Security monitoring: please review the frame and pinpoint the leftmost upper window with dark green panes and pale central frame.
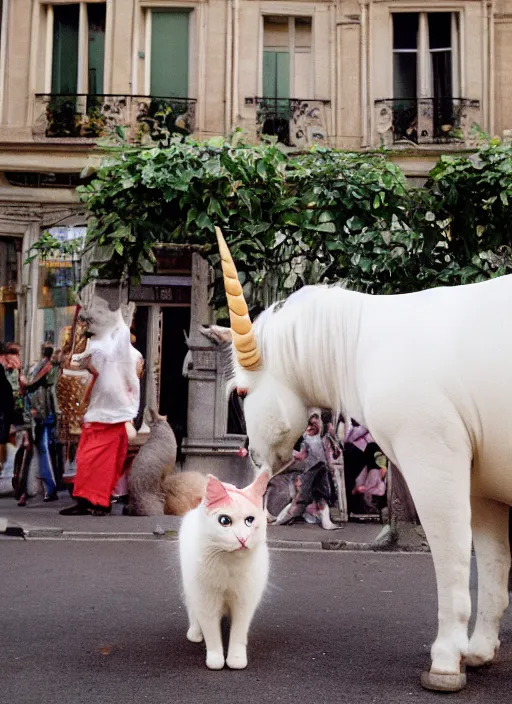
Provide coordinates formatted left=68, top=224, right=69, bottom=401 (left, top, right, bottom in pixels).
left=48, top=3, right=106, bottom=95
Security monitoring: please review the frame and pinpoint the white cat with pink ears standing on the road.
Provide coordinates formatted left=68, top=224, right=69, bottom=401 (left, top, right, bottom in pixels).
left=179, top=473, right=269, bottom=670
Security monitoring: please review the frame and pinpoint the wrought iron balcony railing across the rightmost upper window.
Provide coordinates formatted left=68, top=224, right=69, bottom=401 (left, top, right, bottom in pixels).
left=375, top=98, right=480, bottom=146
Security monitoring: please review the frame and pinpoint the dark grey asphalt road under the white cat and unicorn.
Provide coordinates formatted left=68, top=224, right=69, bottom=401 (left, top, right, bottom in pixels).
left=0, top=539, right=512, bottom=704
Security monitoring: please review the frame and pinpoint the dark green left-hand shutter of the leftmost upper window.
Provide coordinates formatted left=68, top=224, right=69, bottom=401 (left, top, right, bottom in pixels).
left=52, top=4, right=80, bottom=95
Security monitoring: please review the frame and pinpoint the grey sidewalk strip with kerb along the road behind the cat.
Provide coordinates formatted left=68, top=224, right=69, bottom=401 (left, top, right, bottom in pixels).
left=0, top=492, right=421, bottom=550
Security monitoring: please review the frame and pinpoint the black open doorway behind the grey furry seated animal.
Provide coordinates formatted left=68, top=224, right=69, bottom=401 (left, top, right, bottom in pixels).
left=159, top=306, right=190, bottom=452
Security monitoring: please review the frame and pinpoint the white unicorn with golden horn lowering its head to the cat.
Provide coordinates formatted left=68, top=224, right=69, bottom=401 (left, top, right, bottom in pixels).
left=212, top=228, right=512, bottom=691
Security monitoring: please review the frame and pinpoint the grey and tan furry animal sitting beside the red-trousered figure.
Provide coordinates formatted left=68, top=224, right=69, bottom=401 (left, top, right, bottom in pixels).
left=127, top=409, right=206, bottom=516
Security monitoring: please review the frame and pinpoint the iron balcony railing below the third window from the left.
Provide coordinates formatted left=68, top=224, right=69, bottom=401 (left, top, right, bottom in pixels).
left=245, top=98, right=331, bottom=149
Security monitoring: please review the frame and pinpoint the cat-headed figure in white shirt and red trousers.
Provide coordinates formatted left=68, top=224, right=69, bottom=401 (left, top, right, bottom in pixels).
left=61, top=296, right=143, bottom=515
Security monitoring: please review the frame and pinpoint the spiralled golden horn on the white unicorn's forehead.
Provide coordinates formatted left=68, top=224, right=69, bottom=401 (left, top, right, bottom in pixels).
left=215, top=227, right=261, bottom=371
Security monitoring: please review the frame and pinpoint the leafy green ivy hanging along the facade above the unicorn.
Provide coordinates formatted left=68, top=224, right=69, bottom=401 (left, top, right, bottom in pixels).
left=28, top=133, right=512, bottom=317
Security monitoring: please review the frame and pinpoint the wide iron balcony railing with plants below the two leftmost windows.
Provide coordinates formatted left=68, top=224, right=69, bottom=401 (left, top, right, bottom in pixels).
left=32, top=94, right=196, bottom=142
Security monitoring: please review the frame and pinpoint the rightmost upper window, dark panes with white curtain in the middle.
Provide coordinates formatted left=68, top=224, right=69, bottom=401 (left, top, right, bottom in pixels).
left=392, top=12, right=461, bottom=142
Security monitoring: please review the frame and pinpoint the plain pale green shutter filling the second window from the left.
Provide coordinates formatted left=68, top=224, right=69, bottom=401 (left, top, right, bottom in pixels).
left=151, top=10, right=190, bottom=98
